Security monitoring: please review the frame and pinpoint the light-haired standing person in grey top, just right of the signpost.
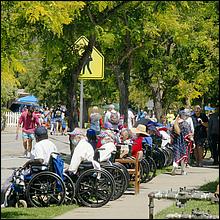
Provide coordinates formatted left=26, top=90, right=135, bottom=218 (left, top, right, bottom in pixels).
left=90, top=106, right=103, bottom=135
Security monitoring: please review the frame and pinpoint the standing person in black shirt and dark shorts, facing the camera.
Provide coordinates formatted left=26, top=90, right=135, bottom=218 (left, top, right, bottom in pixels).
left=192, top=105, right=208, bottom=167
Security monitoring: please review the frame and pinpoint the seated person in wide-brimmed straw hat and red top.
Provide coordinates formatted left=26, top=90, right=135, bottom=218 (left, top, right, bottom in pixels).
left=131, top=124, right=150, bottom=157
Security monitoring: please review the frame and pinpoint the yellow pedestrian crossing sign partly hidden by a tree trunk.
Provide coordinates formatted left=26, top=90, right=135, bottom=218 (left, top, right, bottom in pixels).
left=75, top=36, right=104, bottom=79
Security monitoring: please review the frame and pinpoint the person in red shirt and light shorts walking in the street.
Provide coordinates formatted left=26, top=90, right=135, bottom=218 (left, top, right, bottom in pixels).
left=16, top=106, right=40, bottom=158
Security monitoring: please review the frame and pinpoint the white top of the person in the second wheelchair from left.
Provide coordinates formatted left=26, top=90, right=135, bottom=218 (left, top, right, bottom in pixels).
left=69, top=139, right=100, bottom=173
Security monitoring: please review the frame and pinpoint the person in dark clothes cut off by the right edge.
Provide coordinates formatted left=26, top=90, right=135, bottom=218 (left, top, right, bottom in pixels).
left=208, top=105, right=219, bottom=165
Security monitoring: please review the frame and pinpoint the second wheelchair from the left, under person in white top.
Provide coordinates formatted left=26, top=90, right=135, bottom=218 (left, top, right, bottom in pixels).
left=64, top=148, right=128, bottom=208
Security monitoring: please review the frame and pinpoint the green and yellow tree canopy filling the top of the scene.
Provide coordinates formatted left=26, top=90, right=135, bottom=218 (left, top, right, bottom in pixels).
left=1, top=1, right=219, bottom=123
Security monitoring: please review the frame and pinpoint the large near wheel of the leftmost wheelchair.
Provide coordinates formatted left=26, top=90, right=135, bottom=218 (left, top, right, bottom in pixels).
left=26, top=171, right=66, bottom=207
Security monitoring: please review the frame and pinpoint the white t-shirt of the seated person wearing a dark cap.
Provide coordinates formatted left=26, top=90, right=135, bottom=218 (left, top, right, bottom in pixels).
left=31, top=139, right=58, bottom=164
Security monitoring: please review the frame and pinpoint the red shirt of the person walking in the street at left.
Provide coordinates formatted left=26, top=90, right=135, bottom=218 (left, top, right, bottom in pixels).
left=18, top=111, right=40, bottom=134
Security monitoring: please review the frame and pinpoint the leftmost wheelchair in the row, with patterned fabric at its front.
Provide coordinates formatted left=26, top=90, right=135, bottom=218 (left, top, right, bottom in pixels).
left=1, top=153, right=75, bottom=207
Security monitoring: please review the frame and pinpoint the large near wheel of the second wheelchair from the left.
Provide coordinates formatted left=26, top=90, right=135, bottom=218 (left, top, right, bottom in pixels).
left=76, top=169, right=115, bottom=208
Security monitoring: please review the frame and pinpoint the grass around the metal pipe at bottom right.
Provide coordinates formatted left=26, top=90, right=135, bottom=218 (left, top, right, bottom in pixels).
left=154, top=179, right=219, bottom=219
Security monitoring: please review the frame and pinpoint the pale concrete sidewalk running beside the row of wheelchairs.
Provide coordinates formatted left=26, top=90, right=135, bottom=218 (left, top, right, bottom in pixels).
left=54, top=160, right=219, bottom=219
